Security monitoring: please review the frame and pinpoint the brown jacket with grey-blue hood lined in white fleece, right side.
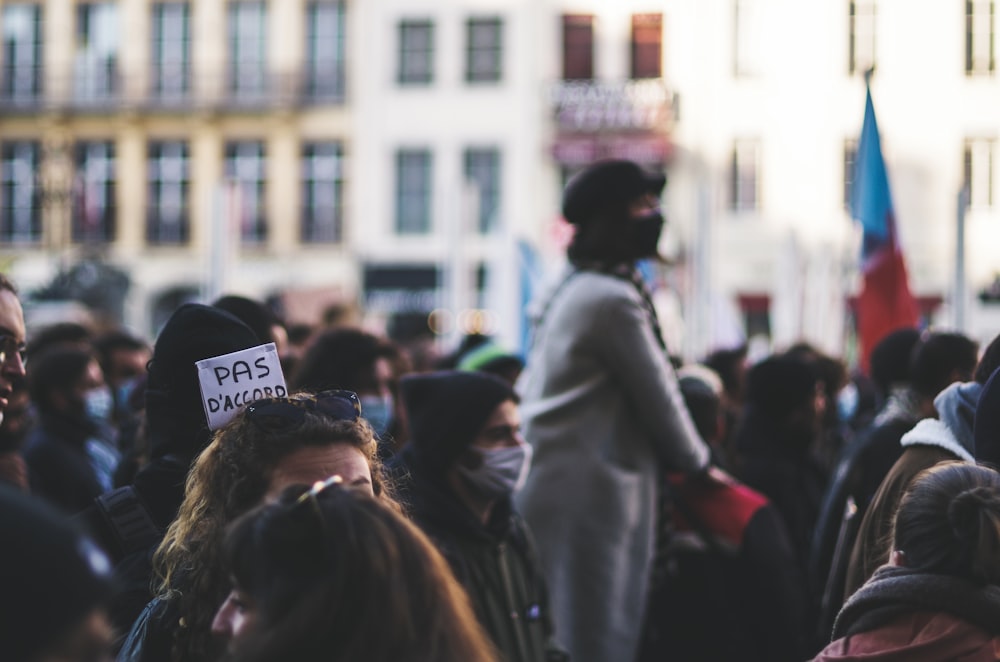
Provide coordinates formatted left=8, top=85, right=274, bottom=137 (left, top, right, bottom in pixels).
left=844, top=382, right=983, bottom=596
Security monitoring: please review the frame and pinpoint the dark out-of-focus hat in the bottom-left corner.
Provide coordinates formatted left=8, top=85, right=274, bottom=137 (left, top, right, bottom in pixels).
left=0, top=485, right=111, bottom=662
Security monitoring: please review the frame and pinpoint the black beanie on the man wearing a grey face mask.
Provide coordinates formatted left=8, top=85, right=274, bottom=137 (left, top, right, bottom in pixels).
left=399, top=371, right=517, bottom=474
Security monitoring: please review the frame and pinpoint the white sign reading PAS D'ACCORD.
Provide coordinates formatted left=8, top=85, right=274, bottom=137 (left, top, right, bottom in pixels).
left=195, top=342, right=288, bottom=430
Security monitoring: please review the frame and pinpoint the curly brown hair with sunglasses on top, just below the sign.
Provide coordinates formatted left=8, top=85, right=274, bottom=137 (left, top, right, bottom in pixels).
left=153, top=392, right=398, bottom=662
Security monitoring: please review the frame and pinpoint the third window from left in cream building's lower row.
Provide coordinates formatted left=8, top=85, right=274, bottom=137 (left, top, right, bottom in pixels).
left=146, top=141, right=191, bottom=244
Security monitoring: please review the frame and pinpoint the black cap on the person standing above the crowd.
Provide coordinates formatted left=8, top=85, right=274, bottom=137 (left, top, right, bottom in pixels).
left=563, top=159, right=667, bottom=225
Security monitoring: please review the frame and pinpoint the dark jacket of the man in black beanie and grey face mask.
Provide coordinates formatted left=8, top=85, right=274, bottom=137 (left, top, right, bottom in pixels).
left=392, top=448, right=568, bottom=662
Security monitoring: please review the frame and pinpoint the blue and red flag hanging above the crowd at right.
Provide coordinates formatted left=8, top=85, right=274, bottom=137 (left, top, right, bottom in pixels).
left=851, top=87, right=918, bottom=372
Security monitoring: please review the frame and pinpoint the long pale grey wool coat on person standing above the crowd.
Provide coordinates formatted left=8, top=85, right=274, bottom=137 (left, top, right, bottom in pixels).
left=517, top=271, right=709, bottom=662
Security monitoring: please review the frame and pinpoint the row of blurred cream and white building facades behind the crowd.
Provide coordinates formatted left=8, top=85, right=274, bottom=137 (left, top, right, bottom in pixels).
left=0, top=0, right=1000, bottom=364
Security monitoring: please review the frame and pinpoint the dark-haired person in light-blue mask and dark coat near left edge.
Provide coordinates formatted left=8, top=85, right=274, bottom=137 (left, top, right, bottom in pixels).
left=24, top=345, right=120, bottom=515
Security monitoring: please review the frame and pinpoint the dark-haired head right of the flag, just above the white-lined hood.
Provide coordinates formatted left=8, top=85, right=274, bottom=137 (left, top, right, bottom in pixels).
left=910, top=333, right=979, bottom=398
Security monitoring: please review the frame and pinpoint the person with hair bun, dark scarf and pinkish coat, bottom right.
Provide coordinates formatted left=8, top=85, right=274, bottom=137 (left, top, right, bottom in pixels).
left=816, top=463, right=1000, bottom=662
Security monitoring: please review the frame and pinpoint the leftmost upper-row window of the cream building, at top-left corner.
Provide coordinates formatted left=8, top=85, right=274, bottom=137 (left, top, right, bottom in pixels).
left=2, top=4, right=42, bottom=103
